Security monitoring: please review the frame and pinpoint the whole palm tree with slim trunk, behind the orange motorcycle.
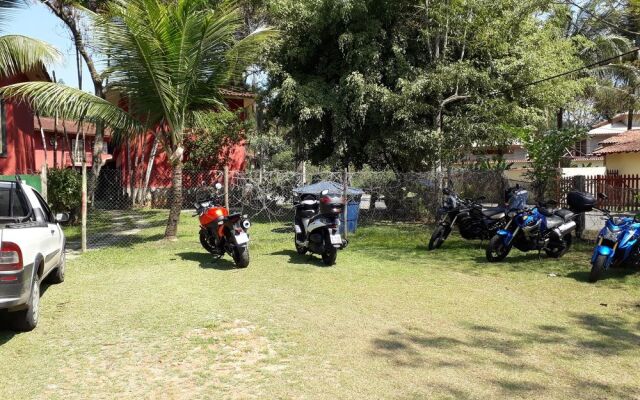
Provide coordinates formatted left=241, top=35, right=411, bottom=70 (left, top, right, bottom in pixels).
left=2, top=0, right=273, bottom=239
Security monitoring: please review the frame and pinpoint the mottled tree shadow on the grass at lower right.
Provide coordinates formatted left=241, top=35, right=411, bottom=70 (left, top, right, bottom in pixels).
left=370, top=313, right=640, bottom=399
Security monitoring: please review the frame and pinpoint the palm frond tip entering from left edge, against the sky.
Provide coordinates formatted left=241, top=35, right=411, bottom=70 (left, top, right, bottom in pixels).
left=0, top=35, right=62, bottom=77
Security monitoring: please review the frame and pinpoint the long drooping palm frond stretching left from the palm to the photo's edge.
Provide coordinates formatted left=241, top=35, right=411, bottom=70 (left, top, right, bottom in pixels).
left=0, top=82, right=143, bottom=132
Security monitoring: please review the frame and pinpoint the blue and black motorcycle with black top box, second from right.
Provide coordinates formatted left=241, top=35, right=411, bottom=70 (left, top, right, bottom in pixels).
left=486, top=190, right=595, bottom=262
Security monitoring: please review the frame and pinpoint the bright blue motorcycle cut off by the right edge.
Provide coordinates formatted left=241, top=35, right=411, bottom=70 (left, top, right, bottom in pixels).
left=589, top=193, right=640, bottom=282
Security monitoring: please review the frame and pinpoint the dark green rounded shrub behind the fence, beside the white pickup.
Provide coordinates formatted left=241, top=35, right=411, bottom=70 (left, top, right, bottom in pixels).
left=47, top=169, right=82, bottom=219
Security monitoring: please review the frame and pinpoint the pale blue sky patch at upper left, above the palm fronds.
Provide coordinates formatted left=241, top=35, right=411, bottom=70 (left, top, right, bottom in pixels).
left=2, top=2, right=93, bottom=92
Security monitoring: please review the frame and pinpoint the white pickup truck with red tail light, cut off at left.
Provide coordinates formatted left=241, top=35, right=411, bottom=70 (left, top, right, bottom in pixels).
left=0, top=179, right=69, bottom=331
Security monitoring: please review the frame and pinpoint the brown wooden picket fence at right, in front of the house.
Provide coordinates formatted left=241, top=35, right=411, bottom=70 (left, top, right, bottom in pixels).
left=557, top=175, right=640, bottom=211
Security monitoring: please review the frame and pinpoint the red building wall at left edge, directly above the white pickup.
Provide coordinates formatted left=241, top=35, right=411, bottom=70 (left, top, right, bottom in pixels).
left=0, top=75, right=41, bottom=175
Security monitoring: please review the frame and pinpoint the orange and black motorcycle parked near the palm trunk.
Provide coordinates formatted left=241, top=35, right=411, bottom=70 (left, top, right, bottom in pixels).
left=193, top=183, right=251, bottom=268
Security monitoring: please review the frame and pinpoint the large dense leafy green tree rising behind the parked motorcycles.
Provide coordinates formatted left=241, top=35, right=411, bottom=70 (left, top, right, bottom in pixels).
left=267, top=0, right=582, bottom=172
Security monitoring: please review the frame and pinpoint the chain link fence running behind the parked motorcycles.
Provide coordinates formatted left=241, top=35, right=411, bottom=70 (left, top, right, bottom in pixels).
left=61, top=169, right=631, bottom=248
